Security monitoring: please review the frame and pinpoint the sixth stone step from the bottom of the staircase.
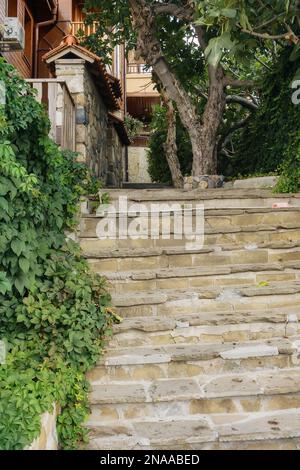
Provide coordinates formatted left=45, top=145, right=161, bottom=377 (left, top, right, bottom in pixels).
left=98, top=259, right=300, bottom=295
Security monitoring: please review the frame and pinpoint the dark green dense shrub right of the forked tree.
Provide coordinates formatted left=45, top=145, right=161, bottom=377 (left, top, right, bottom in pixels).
left=231, top=48, right=300, bottom=176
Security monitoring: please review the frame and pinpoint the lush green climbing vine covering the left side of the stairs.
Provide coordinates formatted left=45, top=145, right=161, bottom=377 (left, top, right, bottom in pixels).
left=0, top=59, right=114, bottom=450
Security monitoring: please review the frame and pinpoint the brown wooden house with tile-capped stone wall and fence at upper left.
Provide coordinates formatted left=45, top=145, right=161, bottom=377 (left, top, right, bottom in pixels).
left=0, top=0, right=129, bottom=187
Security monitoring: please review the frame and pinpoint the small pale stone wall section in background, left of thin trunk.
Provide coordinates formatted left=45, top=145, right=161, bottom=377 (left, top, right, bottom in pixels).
left=128, top=146, right=151, bottom=183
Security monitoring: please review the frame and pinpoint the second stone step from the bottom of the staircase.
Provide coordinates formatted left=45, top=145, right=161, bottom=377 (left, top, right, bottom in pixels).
left=90, top=368, right=300, bottom=404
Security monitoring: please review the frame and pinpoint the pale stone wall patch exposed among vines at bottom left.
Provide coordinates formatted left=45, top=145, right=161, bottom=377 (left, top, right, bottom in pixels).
left=26, top=405, right=59, bottom=450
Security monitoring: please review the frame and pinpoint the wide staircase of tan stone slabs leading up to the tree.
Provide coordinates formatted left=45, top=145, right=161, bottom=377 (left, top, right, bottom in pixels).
left=80, top=189, right=300, bottom=450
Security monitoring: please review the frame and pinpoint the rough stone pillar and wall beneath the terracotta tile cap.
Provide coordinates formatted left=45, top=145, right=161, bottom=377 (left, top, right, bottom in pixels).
left=55, top=59, right=124, bottom=186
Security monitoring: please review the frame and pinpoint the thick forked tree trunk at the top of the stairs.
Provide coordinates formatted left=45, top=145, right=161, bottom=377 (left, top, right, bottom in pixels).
left=129, top=0, right=225, bottom=176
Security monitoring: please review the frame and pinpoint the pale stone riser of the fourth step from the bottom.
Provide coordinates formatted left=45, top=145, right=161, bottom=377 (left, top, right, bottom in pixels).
left=110, top=322, right=300, bottom=349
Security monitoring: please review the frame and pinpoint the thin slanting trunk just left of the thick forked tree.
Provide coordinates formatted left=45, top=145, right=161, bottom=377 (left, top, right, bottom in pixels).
left=161, top=90, right=183, bottom=189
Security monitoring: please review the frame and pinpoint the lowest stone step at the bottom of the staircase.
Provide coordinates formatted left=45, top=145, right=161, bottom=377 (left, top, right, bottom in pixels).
left=88, top=408, right=300, bottom=450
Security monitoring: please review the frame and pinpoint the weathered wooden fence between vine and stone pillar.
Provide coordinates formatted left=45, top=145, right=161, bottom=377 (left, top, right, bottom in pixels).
left=27, top=78, right=76, bottom=150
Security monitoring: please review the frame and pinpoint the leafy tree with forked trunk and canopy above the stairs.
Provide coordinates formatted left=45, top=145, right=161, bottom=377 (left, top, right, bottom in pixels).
left=86, top=0, right=300, bottom=179
